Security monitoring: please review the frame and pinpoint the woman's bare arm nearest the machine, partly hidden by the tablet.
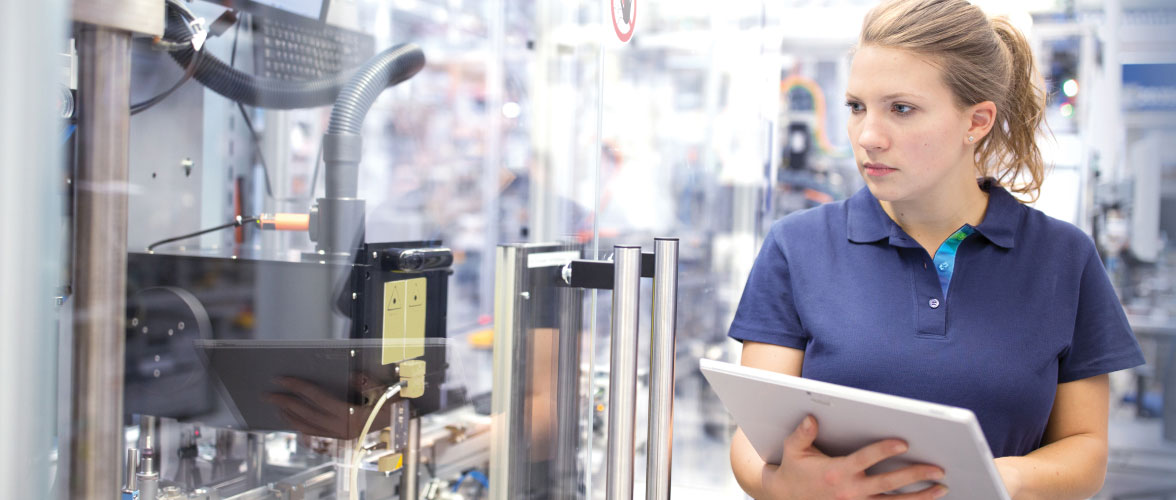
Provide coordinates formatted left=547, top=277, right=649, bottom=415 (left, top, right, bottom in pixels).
left=731, top=341, right=804, bottom=499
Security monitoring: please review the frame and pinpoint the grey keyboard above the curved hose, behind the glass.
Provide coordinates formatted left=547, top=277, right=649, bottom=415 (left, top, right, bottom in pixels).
left=250, top=15, right=375, bottom=80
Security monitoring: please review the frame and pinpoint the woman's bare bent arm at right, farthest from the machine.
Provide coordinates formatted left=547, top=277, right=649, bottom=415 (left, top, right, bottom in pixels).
left=996, top=375, right=1110, bottom=500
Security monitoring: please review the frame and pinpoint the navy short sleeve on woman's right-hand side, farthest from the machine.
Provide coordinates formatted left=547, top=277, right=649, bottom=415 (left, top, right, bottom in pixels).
left=1057, top=248, right=1144, bottom=384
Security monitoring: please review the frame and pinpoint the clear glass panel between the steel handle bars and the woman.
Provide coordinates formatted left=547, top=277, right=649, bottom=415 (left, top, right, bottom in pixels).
left=593, top=1, right=781, bottom=498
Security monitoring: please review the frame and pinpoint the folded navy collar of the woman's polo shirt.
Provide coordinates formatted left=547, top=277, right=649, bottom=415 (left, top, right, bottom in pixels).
left=846, top=179, right=1022, bottom=248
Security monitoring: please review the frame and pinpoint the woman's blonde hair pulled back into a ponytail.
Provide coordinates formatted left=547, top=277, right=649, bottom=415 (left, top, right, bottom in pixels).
left=858, top=0, right=1045, bottom=201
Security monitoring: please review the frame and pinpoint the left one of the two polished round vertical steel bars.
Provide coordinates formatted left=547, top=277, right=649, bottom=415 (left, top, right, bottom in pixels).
left=604, top=245, right=641, bottom=500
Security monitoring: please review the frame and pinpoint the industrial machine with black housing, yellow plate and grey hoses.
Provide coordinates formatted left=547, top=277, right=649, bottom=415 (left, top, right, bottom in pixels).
left=61, top=0, right=505, bottom=500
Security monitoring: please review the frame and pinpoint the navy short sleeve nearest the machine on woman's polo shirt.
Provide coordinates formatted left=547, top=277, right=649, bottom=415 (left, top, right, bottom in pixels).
left=728, top=224, right=808, bottom=349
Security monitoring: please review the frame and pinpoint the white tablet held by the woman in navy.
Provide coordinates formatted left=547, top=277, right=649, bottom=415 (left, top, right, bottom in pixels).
left=699, top=359, right=1009, bottom=500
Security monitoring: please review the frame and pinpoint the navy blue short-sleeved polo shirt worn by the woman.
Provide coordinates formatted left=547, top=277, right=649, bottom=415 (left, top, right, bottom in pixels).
left=729, top=181, right=1143, bottom=456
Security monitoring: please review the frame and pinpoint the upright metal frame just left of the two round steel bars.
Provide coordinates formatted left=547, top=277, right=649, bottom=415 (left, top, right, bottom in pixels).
left=490, top=244, right=583, bottom=500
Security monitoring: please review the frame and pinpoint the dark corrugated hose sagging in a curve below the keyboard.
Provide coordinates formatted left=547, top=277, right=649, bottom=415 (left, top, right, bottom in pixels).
left=163, top=8, right=425, bottom=110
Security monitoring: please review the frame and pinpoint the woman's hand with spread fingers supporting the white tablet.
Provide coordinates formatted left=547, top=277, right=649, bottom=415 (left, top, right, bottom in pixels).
left=762, top=416, right=948, bottom=500
